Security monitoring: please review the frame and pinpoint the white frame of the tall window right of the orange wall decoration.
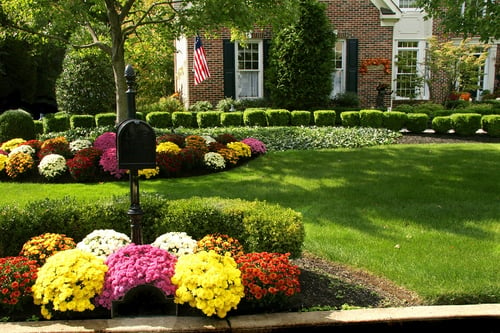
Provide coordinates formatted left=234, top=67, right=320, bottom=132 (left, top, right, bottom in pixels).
left=392, top=39, right=429, bottom=100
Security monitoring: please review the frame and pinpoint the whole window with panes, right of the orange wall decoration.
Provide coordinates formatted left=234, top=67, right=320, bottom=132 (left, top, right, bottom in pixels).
left=396, top=41, right=425, bottom=99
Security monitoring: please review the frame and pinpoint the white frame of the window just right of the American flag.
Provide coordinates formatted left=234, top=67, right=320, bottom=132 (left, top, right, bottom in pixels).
left=234, top=39, right=264, bottom=99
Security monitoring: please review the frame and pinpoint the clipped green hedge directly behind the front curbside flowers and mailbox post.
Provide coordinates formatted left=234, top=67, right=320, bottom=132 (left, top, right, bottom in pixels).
left=0, top=193, right=305, bottom=257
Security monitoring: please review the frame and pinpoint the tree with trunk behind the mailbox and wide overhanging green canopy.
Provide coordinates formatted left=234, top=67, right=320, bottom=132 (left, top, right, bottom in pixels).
left=0, top=0, right=297, bottom=122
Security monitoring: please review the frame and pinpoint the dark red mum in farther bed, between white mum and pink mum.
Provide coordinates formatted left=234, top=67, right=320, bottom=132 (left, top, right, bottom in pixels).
left=66, top=147, right=101, bottom=181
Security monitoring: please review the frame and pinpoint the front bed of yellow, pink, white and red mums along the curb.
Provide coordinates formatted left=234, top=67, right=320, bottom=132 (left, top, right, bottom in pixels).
left=0, top=230, right=300, bottom=320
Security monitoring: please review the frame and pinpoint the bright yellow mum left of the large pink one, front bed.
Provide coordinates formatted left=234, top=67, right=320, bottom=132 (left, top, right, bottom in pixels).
left=33, top=249, right=107, bottom=319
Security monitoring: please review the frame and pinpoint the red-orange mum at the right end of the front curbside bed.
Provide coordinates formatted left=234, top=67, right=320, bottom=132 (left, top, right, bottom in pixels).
left=236, top=252, right=300, bottom=304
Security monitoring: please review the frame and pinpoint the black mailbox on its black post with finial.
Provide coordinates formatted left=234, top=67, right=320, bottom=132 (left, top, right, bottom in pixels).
left=116, top=65, right=156, bottom=245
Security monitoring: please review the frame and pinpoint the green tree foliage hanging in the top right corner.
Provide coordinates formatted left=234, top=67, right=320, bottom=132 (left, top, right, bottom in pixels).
left=417, top=0, right=500, bottom=42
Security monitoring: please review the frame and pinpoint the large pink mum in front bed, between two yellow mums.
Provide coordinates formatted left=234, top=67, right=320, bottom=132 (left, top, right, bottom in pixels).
left=95, top=244, right=177, bottom=309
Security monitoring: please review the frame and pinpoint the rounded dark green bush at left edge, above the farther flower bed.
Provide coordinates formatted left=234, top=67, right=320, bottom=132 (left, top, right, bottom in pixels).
left=0, top=109, right=35, bottom=142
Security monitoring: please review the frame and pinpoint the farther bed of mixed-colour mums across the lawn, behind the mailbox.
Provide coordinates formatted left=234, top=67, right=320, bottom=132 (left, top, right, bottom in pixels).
left=0, top=132, right=266, bottom=182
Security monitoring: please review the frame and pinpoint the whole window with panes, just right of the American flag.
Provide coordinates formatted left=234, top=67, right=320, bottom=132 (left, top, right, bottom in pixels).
left=235, top=41, right=263, bottom=99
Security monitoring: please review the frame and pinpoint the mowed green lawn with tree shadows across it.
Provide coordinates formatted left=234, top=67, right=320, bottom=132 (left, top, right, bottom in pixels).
left=0, top=144, right=500, bottom=304
